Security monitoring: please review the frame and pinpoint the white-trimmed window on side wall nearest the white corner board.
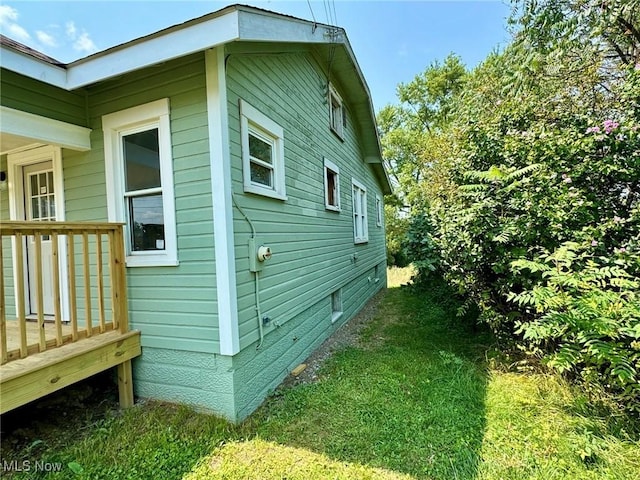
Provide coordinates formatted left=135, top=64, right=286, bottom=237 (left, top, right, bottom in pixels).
left=240, top=100, right=287, bottom=200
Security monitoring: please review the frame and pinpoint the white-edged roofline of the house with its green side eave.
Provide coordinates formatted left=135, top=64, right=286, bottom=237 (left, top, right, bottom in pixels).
left=0, top=5, right=391, bottom=193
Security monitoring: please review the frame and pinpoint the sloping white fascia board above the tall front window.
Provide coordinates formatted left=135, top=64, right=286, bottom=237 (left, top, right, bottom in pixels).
left=66, top=11, right=238, bottom=90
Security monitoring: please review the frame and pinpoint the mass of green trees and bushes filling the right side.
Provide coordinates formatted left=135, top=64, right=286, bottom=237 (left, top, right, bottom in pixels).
left=383, top=0, right=640, bottom=409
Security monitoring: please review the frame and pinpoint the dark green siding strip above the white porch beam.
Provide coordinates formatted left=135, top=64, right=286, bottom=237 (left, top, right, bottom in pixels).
left=0, top=68, right=88, bottom=127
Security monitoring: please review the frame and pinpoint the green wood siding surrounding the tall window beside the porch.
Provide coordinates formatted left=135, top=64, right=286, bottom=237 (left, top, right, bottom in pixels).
left=75, top=54, right=219, bottom=353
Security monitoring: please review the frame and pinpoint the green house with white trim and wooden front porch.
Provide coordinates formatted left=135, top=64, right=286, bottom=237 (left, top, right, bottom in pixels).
left=0, top=6, right=391, bottom=421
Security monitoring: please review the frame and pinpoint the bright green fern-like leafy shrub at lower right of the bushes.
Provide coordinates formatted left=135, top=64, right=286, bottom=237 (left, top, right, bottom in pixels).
left=508, top=242, right=640, bottom=413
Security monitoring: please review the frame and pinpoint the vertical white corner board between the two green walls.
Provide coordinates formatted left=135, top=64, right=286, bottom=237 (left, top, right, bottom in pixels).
left=205, top=47, right=240, bottom=355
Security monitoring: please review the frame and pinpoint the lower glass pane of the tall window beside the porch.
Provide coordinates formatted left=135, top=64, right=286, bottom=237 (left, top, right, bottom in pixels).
left=129, top=194, right=165, bottom=251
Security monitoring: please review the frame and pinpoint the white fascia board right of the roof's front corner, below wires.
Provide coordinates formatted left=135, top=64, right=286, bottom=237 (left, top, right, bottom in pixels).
left=238, top=7, right=346, bottom=43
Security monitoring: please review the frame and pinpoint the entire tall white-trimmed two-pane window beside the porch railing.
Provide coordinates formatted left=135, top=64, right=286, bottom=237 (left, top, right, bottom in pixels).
left=102, top=98, right=178, bottom=267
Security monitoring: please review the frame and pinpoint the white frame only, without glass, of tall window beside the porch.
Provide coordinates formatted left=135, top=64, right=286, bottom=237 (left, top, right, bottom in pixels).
left=102, top=98, right=178, bottom=267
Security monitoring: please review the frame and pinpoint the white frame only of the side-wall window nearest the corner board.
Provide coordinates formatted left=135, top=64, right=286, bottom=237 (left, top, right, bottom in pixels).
left=240, top=100, right=287, bottom=200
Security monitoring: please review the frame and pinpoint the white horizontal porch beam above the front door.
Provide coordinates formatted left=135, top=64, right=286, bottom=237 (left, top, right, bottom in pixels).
left=0, top=106, right=91, bottom=152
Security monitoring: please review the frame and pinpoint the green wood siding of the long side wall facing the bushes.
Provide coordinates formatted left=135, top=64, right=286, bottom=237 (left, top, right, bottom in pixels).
left=227, top=53, right=385, bottom=348
